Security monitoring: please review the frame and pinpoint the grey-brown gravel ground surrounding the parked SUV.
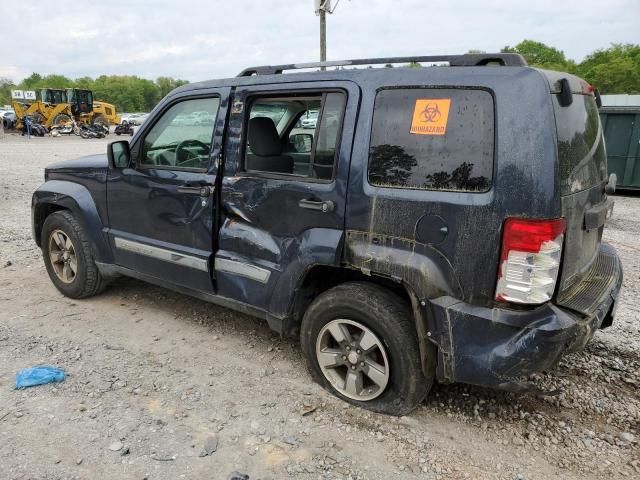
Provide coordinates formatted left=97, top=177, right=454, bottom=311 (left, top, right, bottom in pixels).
left=0, top=134, right=640, bottom=480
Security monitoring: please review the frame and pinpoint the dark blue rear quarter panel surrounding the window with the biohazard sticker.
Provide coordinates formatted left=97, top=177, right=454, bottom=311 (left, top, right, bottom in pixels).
left=346, top=67, right=560, bottom=306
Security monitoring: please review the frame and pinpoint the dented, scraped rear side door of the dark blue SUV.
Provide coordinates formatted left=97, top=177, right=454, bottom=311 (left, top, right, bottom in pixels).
left=215, top=81, right=360, bottom=317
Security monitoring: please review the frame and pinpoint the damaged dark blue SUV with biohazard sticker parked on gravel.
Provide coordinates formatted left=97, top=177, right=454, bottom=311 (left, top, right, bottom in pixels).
left=32, top=53, right=622, bottom=414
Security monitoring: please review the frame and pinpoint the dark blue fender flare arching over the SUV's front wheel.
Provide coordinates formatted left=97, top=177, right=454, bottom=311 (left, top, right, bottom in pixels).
left=31, top=180, right=113, bottom=263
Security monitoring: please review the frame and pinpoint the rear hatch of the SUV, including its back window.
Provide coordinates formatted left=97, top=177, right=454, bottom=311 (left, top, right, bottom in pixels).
left=544, top=71, right=613, bottom=313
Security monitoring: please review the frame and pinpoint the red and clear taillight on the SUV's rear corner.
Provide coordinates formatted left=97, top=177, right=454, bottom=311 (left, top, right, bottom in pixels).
left=496, top=218, right=566, bottom=304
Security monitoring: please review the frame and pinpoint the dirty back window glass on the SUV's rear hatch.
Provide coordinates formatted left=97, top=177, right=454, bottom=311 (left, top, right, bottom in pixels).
left=553, top=95, right=607, bottom=195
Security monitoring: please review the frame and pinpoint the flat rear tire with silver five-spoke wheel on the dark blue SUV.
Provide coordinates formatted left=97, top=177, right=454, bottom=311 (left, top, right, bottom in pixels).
left=300, top=282, right=435, bottom=415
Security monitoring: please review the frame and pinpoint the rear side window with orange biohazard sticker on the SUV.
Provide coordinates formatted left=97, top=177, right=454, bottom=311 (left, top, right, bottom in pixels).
left=368, top=88, right=494, bottom=192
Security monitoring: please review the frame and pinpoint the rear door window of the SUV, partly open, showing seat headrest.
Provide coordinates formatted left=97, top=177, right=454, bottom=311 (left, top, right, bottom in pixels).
left=245, top=92, right=346, bottom=181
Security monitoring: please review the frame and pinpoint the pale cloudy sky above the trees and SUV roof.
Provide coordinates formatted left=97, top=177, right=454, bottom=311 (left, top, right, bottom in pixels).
left=0, top=0, right=640, bottom=82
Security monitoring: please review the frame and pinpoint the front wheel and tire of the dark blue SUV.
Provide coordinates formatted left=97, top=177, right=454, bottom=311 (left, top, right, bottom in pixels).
left=42, top=210, right=105, bottom=298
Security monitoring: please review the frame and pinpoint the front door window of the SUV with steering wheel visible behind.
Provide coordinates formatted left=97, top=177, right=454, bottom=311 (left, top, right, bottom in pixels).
left=141, top=97, right=220, bottom=169
